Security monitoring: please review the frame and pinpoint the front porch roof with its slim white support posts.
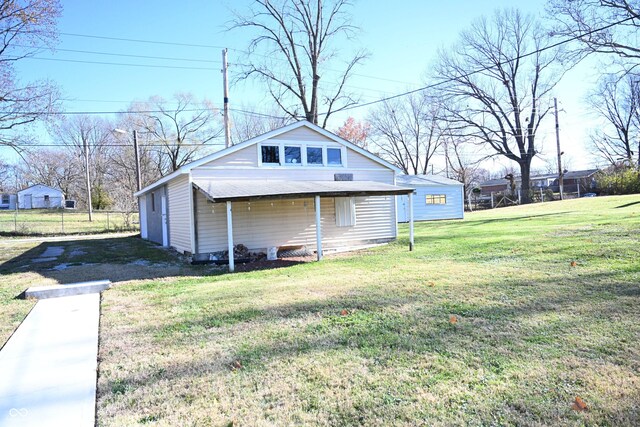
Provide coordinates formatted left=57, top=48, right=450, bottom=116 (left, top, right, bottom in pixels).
left=192, top=178, right=413, bottom=271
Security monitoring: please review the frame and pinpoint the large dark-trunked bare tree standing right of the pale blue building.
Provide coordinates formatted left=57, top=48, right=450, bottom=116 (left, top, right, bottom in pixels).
left=437, top=9, right=563, bottom=203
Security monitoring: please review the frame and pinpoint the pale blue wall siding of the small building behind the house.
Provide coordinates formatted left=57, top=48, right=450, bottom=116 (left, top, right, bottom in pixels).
left=397, top=185, right=464, bottom=222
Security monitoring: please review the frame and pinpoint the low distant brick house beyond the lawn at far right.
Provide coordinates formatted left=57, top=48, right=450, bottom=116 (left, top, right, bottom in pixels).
left=480, top=169, right=599, bottom=196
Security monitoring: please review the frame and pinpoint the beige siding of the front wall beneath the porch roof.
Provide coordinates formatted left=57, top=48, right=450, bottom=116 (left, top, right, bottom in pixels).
left=196, top=194, right=396, bottom=253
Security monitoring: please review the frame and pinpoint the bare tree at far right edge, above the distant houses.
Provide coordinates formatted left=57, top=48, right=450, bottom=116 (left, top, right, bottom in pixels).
left=589, top=74, right=640, bottom=166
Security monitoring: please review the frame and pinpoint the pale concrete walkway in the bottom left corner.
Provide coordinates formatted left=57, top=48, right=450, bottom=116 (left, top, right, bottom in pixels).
left=0, top=293, right=100, bottom=427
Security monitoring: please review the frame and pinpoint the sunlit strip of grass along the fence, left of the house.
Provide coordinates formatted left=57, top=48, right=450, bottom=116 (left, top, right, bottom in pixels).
left=0, top=209, right=138, bottom=236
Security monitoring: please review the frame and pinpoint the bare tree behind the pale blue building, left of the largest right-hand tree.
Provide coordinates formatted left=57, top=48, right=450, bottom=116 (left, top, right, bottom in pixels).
left=367, top=92, right=444, bottom=175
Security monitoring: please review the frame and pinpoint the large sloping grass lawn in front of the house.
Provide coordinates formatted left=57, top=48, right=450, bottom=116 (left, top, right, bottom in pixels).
left=0, top=196, right=640, bottom=426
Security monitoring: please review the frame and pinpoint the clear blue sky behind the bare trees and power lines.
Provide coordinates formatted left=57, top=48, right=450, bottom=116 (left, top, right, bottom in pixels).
left=5, top=0, right=594, bottom=169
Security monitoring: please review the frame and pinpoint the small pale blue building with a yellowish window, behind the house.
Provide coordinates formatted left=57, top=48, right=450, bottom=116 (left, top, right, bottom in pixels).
left=396, top=175, right=464, bottom=222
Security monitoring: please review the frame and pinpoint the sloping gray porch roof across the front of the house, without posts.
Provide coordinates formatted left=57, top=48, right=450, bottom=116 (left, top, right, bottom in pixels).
left=193, top=178, right=414, bottom=203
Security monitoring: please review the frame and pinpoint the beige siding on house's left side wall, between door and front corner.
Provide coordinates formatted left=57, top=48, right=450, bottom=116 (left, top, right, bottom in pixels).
left=167, top=175, right=191, bottom=252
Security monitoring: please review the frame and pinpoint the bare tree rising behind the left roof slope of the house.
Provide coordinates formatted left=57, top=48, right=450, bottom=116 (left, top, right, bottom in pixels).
left=127, top=93, right=223, bottom=175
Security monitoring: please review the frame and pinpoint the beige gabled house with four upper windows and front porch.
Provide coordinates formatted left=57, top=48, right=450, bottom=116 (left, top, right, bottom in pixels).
left=135, top=121, right=413, bottom=270
